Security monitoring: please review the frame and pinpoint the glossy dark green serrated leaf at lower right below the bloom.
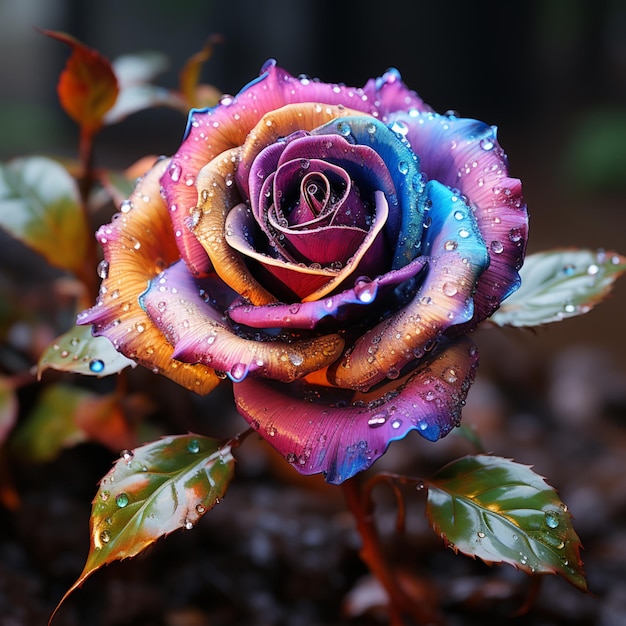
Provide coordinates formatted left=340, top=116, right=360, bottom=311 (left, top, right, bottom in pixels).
left=426, top=455, right=587, bottom=591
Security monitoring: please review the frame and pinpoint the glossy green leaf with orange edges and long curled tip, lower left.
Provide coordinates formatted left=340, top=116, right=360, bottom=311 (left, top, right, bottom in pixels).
left=53, top=435, right=235, bottom=616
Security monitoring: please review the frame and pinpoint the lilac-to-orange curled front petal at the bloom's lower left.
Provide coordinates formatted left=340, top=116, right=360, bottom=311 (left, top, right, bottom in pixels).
left=141, top=262, right=344, bottom=382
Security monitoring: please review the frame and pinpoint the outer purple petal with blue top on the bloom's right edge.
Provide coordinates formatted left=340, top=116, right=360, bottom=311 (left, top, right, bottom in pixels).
left=390, top=112, right=528, bottom=330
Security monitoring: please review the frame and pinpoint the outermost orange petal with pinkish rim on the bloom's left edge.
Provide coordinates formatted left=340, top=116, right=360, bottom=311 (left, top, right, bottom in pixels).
left=77, top=160, right=219, bottom=394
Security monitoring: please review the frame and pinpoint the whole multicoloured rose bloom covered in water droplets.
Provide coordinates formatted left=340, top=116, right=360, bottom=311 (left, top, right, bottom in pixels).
left=79, top=61, right=528, bottom=483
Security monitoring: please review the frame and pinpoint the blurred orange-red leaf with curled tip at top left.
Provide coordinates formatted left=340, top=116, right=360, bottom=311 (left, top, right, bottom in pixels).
left=42, top=30, right=119, bottom=134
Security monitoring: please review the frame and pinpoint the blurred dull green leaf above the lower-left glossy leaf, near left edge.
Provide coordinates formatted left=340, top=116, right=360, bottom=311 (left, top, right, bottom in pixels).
left=11, top=384, right=93, bottom=463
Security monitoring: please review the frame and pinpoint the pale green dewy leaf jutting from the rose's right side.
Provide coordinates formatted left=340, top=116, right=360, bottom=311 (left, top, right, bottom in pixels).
left=491, top=249, right=626, bottom=326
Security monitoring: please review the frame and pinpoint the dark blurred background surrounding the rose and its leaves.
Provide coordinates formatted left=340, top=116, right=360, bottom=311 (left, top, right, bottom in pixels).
left=0, top=0, right=626, bottom=626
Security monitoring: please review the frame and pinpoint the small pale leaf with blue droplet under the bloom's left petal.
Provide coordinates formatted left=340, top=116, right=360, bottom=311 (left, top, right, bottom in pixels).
left=37, top=326, right=136, bottom=378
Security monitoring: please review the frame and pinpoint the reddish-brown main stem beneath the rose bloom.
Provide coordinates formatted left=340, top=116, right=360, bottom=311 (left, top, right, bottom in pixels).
left=342, top=476, right=440, bottom=626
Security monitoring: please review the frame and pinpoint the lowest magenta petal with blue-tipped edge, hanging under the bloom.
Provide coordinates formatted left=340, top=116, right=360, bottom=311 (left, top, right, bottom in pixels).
left=234, top=339, right=478, bottom=484
